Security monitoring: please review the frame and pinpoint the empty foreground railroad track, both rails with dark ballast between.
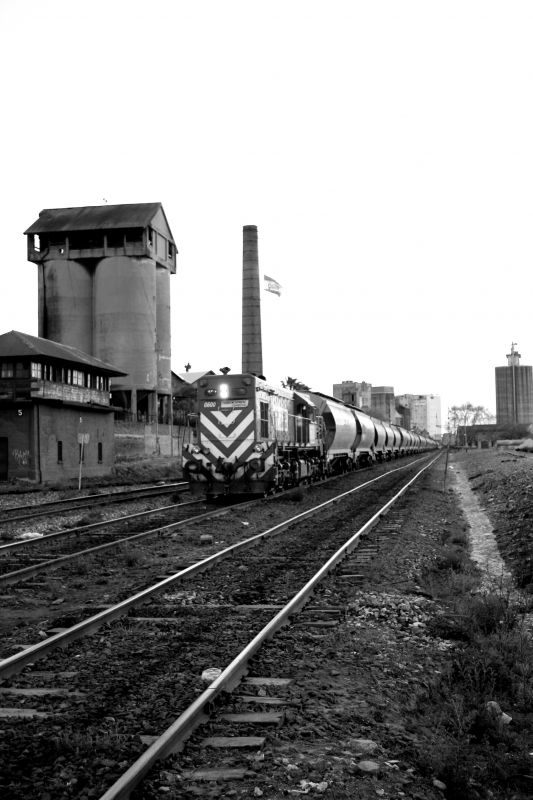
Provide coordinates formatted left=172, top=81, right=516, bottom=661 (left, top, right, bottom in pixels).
left=0, top=459, right=438, bottom=800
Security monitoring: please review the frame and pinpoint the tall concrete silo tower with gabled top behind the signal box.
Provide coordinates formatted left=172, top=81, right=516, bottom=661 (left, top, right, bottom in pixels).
left=25, top=203, right=177, bottom=421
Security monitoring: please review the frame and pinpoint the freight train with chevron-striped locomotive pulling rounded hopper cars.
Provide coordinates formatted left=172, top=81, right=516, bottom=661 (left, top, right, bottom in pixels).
left=183, top=374, right=437, bottom=496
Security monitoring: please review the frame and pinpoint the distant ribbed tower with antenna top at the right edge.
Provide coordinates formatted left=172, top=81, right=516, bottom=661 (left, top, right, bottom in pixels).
left=496, top=342, right=533, bottom=425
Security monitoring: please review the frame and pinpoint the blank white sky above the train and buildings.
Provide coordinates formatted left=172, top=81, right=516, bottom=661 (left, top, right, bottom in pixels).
left=0, top=0, right=533, bottom=424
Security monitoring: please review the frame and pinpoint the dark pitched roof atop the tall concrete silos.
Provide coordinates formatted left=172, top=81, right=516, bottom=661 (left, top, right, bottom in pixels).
left=24, top=203, right=174, bottom=234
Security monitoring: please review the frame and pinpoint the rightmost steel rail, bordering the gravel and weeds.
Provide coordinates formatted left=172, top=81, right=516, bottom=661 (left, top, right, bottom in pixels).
left=100, top=454, right=440, bottom=800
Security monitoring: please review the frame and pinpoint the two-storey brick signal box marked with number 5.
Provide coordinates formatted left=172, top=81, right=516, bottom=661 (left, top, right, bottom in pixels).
left=0, top=331, right=124, bottom=483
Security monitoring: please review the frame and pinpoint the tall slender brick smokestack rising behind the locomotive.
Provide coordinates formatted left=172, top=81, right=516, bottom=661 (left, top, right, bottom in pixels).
left=242, top=225, right=263, bottom=375
